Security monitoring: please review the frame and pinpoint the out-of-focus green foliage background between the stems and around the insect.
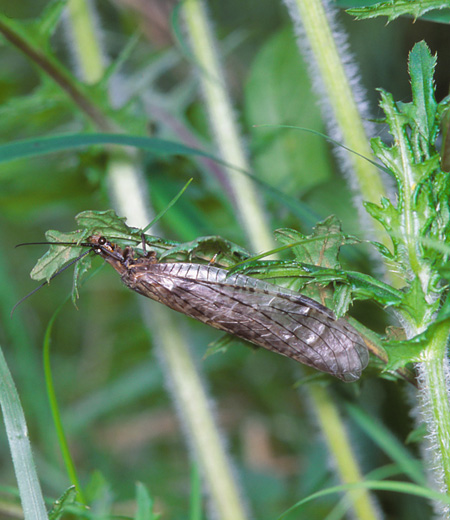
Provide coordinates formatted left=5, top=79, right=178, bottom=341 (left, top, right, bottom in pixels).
left=0, top=0, right=449, bottom=520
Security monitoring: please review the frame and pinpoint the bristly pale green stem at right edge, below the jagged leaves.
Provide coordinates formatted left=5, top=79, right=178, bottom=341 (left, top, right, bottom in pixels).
left=417, top=320, right=450, bottom=500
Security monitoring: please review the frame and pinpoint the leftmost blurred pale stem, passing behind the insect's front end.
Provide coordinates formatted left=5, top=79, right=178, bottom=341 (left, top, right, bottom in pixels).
left=66, top=5, right=247, bottom=520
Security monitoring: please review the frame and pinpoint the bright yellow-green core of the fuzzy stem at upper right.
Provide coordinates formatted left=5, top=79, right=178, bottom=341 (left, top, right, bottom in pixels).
left=287, top=0, right=391, bottom=252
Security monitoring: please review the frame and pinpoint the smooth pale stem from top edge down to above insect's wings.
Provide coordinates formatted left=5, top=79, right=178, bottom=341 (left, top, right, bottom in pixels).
left=183, top=0, right=274, bottom=252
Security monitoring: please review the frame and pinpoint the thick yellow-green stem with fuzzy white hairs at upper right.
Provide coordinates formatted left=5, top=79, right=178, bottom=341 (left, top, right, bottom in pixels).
left=285, top=0, right=391, bottom=254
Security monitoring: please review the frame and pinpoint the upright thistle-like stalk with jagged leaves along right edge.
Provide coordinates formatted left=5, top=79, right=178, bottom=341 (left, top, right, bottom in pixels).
left=376, top=60, right=450, bottom=508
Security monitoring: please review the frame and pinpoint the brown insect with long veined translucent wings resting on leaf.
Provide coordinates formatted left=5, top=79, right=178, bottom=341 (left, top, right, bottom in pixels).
left=88, top=235, right=369, bottom=382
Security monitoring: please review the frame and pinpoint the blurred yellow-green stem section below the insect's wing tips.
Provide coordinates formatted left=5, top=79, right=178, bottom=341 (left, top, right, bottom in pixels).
left=309, top=384, right=380, bottom=520
